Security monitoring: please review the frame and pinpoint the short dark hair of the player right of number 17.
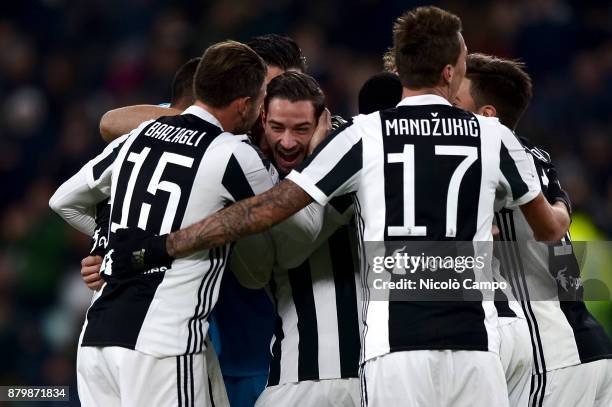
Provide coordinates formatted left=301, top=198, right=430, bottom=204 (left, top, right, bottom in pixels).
left=466, top=54, right=533, bottom=129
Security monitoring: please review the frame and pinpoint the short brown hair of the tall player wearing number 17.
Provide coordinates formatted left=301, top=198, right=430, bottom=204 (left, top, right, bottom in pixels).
left=393, top=6, right=461, bottom=89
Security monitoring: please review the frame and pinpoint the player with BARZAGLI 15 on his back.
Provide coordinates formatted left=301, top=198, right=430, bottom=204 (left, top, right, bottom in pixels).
left=50, top=41, right=316, bottom=405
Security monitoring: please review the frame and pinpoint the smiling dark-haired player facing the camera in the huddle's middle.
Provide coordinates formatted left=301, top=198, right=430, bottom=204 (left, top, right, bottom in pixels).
left=232, top=72, right=361, bottom=407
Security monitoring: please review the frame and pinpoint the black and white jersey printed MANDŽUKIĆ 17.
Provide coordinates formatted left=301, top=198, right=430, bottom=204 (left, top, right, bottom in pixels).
left=288, top=95, right=540, bottom=361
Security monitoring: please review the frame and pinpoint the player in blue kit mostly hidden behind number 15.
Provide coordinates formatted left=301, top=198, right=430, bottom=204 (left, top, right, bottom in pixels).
left=83, top=34, right=310, bottom=405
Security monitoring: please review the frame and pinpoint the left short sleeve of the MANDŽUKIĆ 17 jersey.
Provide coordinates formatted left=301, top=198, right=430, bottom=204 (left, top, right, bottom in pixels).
left=287, top=122, right=363, bottom=205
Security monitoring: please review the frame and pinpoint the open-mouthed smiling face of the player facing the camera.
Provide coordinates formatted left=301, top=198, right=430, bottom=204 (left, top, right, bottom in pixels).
left=264, top=98, right=317, bottom=174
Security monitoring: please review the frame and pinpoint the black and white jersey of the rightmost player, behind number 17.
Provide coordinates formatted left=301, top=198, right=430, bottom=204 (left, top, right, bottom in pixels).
left=495, top=140, right=612, bottom=376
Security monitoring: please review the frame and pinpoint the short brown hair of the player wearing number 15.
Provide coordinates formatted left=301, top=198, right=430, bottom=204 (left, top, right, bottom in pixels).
left=193, top=41, right=266, bottom=108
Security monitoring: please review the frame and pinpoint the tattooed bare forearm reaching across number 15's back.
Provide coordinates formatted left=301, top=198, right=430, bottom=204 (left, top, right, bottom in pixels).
left=166, top=180, right=312, bottom=257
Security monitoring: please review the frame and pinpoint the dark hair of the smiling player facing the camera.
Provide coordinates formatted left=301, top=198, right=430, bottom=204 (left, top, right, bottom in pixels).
left=264, top=71, right=325, bottom=120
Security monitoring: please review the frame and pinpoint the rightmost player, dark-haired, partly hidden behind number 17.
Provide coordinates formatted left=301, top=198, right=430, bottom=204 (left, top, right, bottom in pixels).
left=456, top=54, right=612, bottom=407
